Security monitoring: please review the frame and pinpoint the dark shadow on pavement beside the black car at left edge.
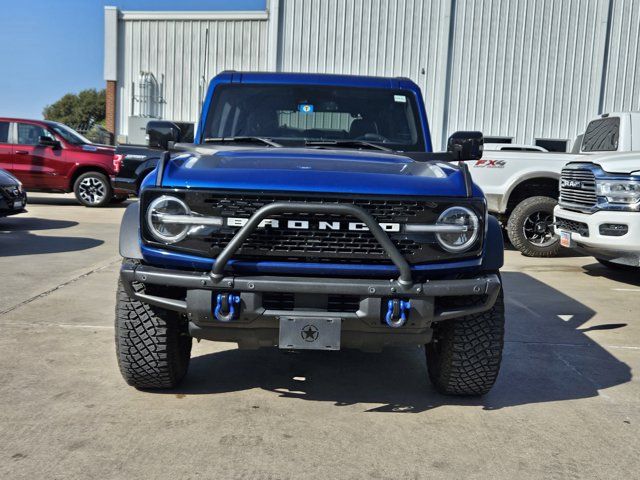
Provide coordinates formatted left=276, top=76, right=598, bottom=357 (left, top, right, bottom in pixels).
left=0, top=217, right=104, bottom=257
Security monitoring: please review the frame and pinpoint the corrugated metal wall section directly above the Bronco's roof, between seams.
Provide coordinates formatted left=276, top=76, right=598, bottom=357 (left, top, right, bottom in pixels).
left=277, top=0, right=451, bottom=146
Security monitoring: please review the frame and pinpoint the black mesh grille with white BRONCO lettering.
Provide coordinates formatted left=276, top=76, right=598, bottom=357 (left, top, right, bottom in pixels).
left=142, top=190, right=484, bottom=264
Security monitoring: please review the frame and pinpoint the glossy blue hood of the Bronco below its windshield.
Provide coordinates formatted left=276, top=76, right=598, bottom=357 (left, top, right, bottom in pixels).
left=162, top=147, right=481, bottom=197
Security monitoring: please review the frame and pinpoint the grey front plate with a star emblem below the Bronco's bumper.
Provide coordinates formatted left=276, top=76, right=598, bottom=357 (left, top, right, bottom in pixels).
left=278, top=317, right=342, bottom=350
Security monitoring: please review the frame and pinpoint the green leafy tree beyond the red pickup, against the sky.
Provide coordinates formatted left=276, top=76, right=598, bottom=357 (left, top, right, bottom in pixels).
left=42, top=88, right=106, bottom=127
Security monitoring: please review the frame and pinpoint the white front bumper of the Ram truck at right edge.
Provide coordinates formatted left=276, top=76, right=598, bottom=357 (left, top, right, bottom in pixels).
left=553, top=206, right=640, bottom=266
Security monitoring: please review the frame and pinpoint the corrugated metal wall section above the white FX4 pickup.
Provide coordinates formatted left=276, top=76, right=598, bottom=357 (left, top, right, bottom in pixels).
left=444, top=0, right=608, bottom=148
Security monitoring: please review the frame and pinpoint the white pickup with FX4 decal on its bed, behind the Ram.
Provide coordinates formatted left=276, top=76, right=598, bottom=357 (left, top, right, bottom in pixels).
left=467, top=112, right=640, bottom=257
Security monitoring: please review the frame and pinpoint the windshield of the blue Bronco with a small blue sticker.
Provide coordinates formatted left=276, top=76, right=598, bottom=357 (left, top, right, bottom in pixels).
left=203, top=84, right=425, bottom=151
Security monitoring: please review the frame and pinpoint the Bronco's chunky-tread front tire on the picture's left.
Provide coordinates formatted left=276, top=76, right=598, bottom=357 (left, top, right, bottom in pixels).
left=115, top=280, right=191, bottom=389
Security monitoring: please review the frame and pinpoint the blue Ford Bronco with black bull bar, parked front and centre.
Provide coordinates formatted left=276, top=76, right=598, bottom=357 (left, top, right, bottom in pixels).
left=116, top=72, right=504, bottom=395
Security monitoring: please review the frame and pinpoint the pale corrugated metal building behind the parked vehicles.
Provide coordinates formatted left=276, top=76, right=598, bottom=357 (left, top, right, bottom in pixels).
left=104, top=0, right=640, bottom=150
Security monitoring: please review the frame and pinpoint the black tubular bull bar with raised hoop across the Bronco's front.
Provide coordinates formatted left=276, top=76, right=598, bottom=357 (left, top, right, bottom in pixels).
left=121, top=202, right=501, bottom=321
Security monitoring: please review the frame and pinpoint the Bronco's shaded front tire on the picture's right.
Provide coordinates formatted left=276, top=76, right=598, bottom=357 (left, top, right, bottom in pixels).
left=425, top=291, right=504, bottom=396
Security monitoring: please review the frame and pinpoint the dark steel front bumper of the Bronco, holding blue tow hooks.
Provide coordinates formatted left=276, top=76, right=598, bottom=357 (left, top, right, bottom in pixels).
left=120, top=261, right=501, bottom=350
